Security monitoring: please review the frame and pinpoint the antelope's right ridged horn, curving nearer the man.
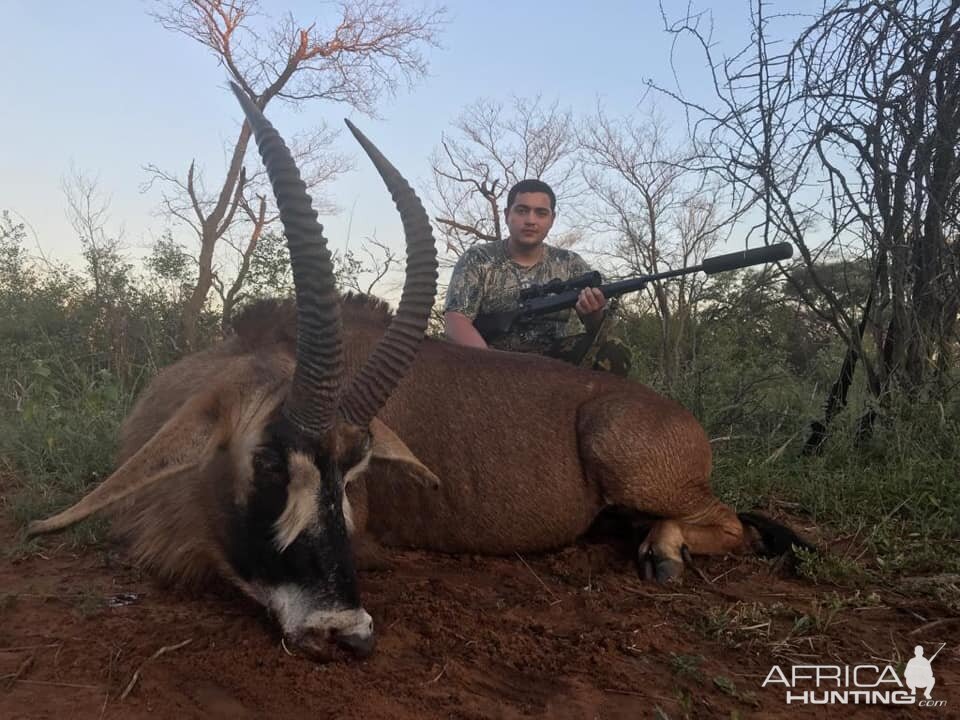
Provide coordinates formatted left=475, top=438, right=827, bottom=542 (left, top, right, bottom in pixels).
left=340, top=120, right=437, bottom=426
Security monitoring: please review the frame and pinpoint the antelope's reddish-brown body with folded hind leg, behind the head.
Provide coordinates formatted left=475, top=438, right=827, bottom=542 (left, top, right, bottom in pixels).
left=288, top=299, right=807, bottom=581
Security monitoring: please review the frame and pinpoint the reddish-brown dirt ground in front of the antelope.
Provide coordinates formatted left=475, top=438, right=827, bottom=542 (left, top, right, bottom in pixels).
left=0, top=492, right=960, bottom=720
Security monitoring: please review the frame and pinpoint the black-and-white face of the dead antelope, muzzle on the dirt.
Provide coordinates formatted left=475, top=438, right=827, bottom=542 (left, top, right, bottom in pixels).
left=227, top=423, right=375, bottom=660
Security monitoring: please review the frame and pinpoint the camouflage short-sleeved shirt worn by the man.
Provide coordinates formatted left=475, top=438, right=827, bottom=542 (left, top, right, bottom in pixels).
left=443, top=240, right=590, bottom=353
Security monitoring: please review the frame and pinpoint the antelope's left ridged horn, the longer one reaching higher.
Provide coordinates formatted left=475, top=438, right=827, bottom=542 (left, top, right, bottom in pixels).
left=230, top=82, right=343, bottom=438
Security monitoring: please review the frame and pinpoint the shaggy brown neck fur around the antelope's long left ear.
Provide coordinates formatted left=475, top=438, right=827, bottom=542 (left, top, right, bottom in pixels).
left=111, top=346, right=294, bottom=584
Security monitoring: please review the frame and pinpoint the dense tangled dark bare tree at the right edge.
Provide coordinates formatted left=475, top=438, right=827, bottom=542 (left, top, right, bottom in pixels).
left=658, top=0, right=960, bottom=449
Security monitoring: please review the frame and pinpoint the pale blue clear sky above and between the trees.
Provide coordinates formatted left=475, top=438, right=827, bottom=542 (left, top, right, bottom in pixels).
left=0, top=0, right=808, bottom=296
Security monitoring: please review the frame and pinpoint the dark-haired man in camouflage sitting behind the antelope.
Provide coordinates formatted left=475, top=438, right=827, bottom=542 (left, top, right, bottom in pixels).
left=443, top=180, right=629, bottom=375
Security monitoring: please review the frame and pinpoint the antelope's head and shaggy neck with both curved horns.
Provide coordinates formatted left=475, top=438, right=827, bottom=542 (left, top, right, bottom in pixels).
left=28, top=86, right=437, bottom=656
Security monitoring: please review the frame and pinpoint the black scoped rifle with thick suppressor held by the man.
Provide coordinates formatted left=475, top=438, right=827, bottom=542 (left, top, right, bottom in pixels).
left=473, top=243, right=793, bottom=342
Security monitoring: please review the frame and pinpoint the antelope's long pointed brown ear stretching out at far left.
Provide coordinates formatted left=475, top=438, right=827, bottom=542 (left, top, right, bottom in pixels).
left=27, top=396, right=219, bottom=536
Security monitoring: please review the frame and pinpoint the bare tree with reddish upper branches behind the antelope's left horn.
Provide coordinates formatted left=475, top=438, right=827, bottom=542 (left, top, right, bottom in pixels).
left=148, top=0, right=444, bottom=347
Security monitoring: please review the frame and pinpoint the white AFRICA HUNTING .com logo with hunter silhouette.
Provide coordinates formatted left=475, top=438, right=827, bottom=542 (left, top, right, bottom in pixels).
left=762, top=643, right=947, bottom=707
